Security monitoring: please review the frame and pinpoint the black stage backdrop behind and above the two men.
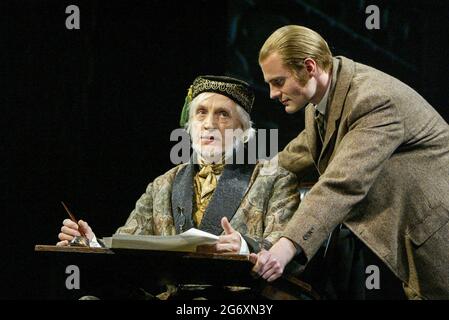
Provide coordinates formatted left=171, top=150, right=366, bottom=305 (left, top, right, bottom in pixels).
left=0, top=0, right=449, bottom=299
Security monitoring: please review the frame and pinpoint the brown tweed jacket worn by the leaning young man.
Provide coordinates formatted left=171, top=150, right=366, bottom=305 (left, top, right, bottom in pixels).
left=279, top=57, right=449, bottom=299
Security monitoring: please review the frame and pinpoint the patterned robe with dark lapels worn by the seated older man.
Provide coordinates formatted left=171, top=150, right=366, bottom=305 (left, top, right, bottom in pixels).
left=117, top=164, right=299, bottom=252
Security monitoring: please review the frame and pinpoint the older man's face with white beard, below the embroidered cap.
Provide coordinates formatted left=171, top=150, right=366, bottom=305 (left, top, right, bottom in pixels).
left=191, top=93, right=242, bottom=162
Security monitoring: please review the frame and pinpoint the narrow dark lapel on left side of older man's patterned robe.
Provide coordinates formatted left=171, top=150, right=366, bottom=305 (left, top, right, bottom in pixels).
left=171, top=163, right=195, bottom=233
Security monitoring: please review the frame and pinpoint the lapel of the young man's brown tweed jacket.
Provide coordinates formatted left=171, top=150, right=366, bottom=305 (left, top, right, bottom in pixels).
left=318, top=57, right=355, bottom=172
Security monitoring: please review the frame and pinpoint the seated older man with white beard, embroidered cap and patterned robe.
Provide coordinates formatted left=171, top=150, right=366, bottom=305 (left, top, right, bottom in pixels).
left=58, top=76, right=299, bottom=296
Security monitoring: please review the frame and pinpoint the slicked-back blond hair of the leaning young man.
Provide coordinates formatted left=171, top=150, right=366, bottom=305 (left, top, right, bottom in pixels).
left=259, top=25, right=332, bottom=79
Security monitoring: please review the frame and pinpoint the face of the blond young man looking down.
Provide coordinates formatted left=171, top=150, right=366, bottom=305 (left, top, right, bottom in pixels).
left=260, top=52, right=317, bottom=113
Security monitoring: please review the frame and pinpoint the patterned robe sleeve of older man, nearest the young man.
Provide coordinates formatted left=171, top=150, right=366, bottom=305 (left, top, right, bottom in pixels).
left=242, top=170, right=299, bottom=252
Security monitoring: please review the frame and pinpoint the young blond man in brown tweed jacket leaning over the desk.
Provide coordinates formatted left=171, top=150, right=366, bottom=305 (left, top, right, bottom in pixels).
left=252, top=26, right=449, bottom=299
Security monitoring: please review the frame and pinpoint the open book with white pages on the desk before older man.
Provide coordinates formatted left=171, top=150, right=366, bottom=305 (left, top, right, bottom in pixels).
left=103, top=228, right=218, bottom=252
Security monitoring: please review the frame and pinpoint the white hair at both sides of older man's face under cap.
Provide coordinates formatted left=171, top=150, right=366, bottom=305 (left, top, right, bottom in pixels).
left=185, top=92, right=256, bottom=143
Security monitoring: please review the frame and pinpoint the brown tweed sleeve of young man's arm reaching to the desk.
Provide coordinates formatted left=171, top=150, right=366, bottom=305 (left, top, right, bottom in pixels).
left=282, top=100, right=404, bottom=260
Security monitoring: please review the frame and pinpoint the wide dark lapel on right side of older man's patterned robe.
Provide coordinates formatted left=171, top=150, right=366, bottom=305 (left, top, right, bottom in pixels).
left=199, top=164, right=255, bottom=235
